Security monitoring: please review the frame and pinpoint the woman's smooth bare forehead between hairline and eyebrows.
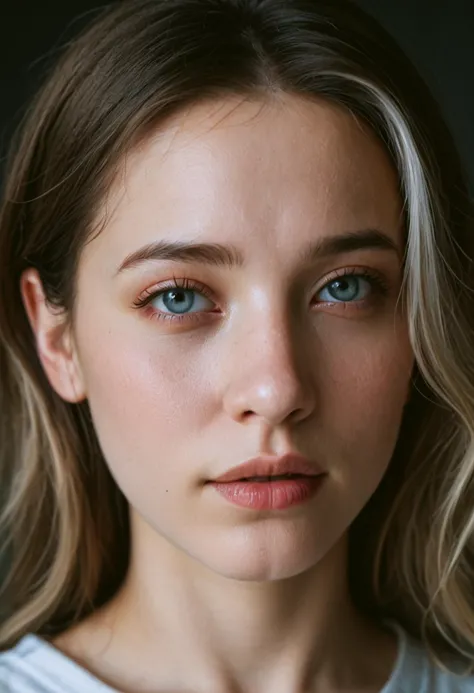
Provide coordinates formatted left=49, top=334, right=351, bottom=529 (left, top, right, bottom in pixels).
left=88, top=95, right=400, bottom=270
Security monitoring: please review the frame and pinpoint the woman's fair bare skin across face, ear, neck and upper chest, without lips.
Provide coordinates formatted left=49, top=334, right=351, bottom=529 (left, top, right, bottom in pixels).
left=22, top=95, right=413, bottom=693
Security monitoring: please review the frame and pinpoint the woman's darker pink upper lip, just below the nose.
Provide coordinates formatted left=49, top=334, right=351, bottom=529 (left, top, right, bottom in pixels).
left=213, top=453, right=323, bottom=482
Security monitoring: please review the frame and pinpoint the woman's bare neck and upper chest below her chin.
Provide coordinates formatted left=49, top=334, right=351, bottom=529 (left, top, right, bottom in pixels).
left=53, top=518, right=396, bottom=693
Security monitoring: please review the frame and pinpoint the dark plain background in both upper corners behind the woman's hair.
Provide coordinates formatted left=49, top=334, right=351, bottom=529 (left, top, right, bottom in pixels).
left=0, top=0, right=474, bottom=190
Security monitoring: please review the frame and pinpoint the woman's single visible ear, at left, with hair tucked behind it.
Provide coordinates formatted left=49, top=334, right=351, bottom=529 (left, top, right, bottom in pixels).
left=20, top=268, right=86, bottom=402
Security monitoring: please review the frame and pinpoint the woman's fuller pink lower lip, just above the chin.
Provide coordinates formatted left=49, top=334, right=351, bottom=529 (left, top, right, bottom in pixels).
left=210, top=474, right=324, bottom=510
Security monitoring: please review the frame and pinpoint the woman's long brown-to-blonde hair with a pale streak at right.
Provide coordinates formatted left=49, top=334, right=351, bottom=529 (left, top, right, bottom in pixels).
left=0, top=0, right=474, bottom=663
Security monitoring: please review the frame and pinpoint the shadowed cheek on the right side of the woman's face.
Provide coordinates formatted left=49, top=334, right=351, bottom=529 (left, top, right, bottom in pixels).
left=321, top=321, right=414, bottom=494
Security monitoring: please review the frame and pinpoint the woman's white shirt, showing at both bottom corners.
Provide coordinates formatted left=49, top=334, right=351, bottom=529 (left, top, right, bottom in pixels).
left=0, top=625, right=474, bottom=693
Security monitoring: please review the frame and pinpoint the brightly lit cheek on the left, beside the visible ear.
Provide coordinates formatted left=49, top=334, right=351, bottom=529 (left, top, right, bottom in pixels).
left=76, top=325, right=215, bottom=478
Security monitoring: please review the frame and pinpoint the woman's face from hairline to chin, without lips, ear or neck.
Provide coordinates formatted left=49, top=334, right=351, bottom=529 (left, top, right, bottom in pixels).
left=41, top=96, right=413, bottom=580
